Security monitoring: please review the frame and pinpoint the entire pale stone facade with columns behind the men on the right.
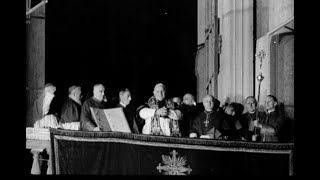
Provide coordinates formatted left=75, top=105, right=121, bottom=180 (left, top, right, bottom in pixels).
left=196, top=0, right=294, bottom=117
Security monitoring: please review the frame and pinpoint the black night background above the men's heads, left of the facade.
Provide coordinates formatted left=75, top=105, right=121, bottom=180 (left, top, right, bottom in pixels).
left=45, top=0, right=197, bottom=114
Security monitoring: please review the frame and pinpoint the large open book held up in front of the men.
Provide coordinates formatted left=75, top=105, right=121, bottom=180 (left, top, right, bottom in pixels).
left=90, top=107, right=131, bottom=133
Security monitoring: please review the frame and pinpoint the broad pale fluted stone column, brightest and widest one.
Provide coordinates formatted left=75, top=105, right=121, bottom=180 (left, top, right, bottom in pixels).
left=218, top=0, right=254, bottom=104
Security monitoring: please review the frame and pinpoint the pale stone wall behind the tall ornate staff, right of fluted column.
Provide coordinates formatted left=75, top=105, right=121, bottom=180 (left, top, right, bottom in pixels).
left=255, top=0, right=294, bottom=106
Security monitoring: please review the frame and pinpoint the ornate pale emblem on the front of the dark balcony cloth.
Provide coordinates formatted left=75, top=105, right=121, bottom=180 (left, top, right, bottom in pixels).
left=157, top=150, right=192, bottom=175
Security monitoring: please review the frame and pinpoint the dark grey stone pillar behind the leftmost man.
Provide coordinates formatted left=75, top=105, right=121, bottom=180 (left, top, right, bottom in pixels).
left=26, top=2, right=45, bottom=127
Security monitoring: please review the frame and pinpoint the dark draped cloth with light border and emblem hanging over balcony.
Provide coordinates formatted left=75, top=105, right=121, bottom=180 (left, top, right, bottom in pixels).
left=50, top=129, right=293, bottom=176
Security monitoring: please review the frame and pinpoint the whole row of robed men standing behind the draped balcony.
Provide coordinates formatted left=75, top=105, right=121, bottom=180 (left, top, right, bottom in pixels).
left=30, top=83, right=286, bottom=142
